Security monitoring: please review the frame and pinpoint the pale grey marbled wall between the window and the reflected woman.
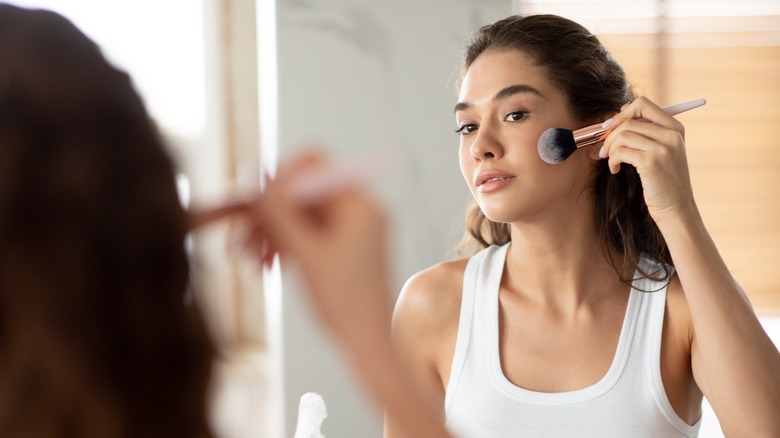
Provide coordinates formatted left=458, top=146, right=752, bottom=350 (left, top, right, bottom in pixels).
left=258, top=0, right=512, bottom=438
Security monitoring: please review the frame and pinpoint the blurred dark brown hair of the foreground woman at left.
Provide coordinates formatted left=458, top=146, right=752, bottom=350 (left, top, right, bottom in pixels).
left=0, top=5, right=213, bottom=438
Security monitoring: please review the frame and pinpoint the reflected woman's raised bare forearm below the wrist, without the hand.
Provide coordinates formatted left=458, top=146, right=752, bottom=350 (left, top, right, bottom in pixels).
left=659, top=206, right=780, bottom=436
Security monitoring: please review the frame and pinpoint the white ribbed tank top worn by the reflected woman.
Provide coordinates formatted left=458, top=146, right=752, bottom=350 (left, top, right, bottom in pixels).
left=444, top=244, right=701, bottom=438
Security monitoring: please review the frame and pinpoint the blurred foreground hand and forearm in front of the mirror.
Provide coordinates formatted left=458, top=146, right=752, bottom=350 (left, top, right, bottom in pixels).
left=256, top=159, right=449, bottom=438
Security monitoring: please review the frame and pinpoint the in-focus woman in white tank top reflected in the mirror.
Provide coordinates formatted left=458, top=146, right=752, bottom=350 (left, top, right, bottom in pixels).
left=386, top=15, right=780, bottom=438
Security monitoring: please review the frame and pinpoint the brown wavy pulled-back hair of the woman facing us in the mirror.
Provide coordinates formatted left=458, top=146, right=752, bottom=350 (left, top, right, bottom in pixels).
left=463, top=15, right=672, bottom=282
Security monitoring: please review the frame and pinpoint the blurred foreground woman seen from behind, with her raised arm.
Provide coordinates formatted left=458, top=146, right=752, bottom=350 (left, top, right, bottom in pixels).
left=0, top=4, right=445, bottom=438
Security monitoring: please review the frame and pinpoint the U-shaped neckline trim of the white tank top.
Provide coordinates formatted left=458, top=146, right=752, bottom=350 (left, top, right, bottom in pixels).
left=485, top=243, right=640, bottom=404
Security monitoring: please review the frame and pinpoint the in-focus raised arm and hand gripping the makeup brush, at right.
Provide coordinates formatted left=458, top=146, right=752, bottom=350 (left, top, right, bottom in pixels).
left=601, top=98, right=780, bottom=436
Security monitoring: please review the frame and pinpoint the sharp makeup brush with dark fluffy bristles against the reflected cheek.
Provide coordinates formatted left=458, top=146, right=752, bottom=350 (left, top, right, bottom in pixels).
left=536, top=99, right=707, bottom=164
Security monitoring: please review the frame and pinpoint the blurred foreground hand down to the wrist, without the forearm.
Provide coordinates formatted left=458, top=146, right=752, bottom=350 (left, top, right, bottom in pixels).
left=255, top=155, right=391, bottom=347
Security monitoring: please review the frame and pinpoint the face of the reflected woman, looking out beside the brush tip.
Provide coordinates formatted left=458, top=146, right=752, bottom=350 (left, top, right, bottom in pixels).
left=455, top=50, right=597, bottom=223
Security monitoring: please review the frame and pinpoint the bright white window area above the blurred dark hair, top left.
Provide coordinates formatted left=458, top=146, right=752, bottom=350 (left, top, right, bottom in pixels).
left=9, top=0, right=205, bottom=139
